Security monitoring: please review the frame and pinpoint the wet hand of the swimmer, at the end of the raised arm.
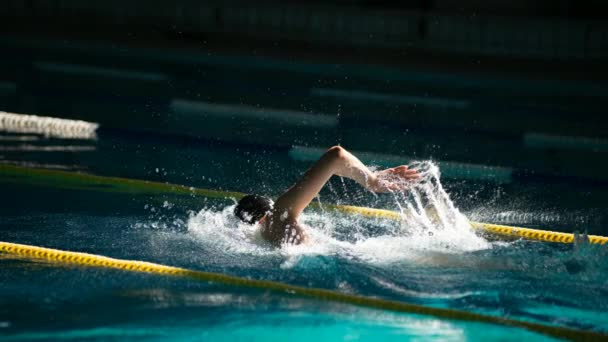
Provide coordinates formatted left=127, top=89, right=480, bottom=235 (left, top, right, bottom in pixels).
left=367, top=165, right=421, bottom=192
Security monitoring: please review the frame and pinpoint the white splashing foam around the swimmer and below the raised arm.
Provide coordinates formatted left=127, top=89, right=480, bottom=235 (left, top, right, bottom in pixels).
left=187, top=162, right=491, bottom=267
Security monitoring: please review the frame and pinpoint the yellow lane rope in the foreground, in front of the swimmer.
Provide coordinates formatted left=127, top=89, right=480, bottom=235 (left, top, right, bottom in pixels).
left=0, top=241, right=608, bottom=341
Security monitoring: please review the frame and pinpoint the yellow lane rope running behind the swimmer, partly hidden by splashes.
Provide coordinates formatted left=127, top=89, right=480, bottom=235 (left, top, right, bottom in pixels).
left=0, top=164, right=608, bottom=245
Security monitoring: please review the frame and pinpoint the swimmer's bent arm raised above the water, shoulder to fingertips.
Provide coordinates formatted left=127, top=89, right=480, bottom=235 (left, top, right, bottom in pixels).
left=272, top=146, right=420, bottom=225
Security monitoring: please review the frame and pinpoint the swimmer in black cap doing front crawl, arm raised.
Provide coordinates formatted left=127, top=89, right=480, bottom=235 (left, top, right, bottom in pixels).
left=234, top=146, right=420, bottom=246
